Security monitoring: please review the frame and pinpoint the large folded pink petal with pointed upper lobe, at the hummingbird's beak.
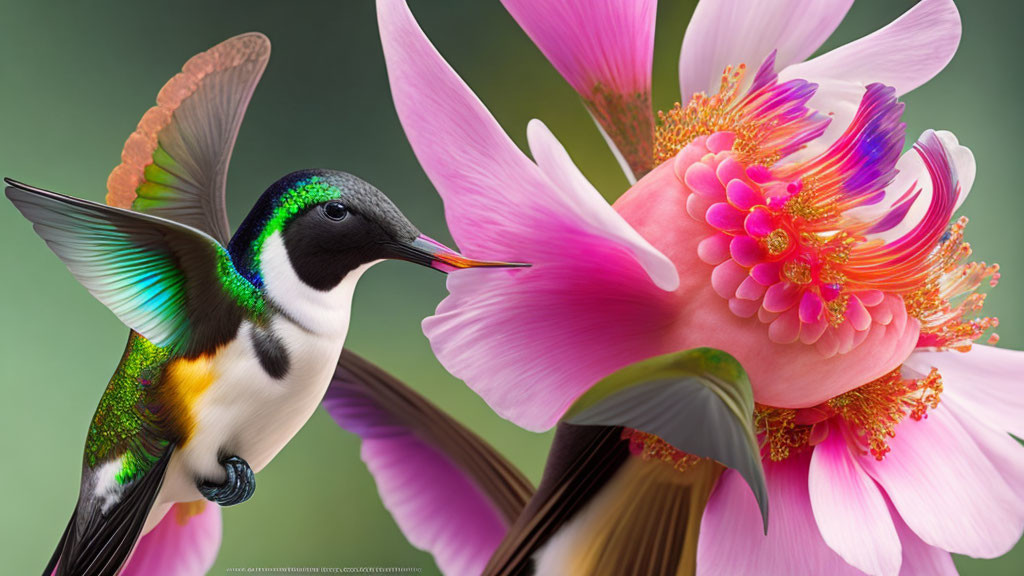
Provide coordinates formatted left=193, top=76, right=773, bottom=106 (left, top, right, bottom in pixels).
left=379, top=0, right=689, bottom=429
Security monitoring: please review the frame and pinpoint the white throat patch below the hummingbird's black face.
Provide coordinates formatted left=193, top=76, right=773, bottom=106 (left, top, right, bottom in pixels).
left=260, top=232, right=380, bottom=337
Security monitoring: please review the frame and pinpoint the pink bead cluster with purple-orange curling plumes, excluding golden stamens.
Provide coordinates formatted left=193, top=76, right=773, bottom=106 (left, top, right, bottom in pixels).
left=676, top=68, right=978, bottom=357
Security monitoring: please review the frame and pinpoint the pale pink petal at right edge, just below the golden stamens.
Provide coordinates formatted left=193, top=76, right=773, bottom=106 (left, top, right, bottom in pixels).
left=906, top=344, right=1024, bottom=438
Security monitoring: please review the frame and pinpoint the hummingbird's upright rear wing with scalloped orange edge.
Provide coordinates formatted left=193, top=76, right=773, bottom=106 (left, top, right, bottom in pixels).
left=106, top=33, right=270, bottom=241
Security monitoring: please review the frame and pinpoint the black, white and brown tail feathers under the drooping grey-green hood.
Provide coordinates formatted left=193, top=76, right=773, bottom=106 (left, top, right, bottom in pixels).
left=484, top=423, right=724, bottom=576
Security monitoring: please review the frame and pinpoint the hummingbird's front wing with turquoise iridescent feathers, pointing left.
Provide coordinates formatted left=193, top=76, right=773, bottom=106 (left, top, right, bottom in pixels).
left=6, top=179, right=263, bottom=356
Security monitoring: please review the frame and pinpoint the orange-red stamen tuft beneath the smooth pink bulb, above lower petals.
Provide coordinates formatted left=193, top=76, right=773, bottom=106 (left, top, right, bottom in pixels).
left=754, top=367, right=942, bottom=461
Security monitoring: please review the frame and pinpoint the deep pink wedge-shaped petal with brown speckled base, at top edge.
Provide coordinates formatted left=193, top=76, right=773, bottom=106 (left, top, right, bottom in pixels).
left=502, top=0, right=657, bottom=176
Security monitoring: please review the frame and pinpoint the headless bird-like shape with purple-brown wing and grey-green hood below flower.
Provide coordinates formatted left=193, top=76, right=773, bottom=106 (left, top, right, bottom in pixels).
left=324, top=348, right=768, bottom=576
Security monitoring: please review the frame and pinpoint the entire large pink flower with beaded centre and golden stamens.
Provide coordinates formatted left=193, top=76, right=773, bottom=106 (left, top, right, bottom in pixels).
left=378, top=0, right=1024, bottom=574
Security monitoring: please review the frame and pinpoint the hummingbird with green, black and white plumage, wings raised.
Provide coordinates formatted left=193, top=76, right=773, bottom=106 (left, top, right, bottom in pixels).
left=5, top=33, right=520, bottom=576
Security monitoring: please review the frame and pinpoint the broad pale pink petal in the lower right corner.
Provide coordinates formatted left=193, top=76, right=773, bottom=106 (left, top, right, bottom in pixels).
left=860, top=406, right=1024, bottom=558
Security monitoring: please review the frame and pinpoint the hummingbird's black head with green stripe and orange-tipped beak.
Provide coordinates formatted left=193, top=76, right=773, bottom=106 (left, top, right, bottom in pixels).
left=229, top=166, right=516, bottom=292
